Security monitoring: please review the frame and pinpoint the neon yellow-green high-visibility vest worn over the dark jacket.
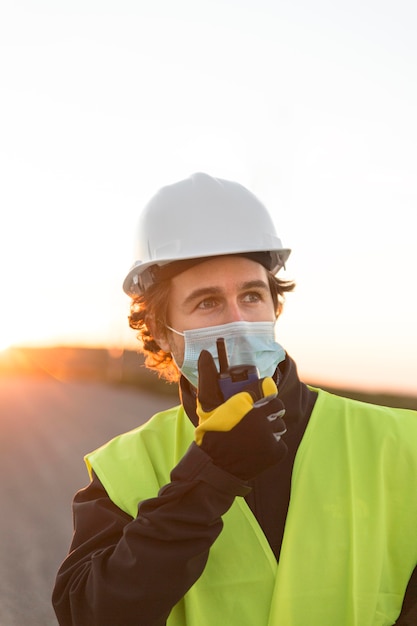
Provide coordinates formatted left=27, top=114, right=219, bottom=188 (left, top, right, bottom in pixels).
left=86, top=390, right=417, bottom=626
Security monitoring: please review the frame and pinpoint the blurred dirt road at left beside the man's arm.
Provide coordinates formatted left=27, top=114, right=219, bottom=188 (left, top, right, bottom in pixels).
left=0, top=378, right=175, bottom=626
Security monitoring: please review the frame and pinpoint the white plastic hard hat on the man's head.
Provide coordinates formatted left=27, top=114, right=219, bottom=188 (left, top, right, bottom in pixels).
left=123, top=173, right=291, bottom=296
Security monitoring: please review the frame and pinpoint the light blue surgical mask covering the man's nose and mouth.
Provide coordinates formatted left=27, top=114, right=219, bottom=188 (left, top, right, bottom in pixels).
left=167, top=322, right=285, bottom=387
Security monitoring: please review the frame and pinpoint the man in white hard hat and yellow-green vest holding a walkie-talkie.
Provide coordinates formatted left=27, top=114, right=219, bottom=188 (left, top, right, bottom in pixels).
left=53, top=174, right=417, bottom=626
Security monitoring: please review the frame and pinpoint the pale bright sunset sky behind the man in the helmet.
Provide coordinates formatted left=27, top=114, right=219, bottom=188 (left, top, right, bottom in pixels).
left=0, top=0, right=417, bottom=393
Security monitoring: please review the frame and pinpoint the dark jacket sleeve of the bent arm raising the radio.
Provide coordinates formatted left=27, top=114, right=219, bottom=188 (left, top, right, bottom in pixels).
left=53, top=443, right=250, bottom=626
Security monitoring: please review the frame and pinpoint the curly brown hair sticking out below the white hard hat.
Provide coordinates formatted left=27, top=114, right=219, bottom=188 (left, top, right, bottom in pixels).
left=128, top=272, right=295, bottom=382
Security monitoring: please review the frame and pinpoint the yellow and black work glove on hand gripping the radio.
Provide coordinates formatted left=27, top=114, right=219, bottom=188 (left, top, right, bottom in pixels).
left=195, top=350, right=287, bottom=480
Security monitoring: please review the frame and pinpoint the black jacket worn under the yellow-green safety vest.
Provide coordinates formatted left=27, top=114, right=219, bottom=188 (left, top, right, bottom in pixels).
left=53, top=356, right=417, bottom=626
